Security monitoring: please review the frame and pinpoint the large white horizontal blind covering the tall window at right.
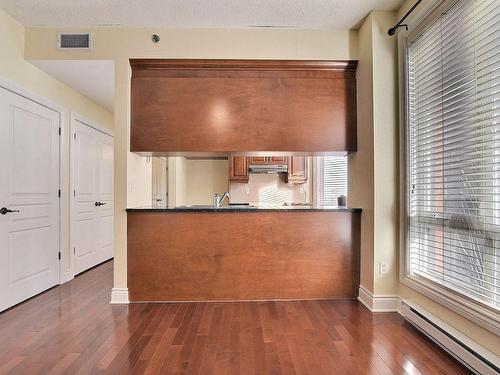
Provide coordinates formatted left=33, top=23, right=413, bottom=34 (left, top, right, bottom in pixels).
left=407, top=0, right=500, bottom=309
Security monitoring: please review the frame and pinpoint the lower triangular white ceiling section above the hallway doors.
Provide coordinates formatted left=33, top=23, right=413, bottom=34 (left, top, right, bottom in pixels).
left=30, top=60, right=115, bottom=113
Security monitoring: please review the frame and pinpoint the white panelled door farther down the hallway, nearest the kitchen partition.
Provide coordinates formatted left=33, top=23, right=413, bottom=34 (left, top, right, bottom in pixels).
left=72, top=120, right=114, bottom=274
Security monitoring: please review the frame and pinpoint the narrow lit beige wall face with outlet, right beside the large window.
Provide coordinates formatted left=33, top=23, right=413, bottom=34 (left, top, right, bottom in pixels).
left=371, top=12, right=399, bottom=295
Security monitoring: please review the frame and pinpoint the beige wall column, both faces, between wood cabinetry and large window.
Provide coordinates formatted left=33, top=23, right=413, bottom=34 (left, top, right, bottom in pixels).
left=349, top=12, right=398, bottom=295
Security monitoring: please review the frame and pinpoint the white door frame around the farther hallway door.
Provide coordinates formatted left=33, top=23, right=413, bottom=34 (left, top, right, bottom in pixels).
left=67, top=111, right=115, bottom=278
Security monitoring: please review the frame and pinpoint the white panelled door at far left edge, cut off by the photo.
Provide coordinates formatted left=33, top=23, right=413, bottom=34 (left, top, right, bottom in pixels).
left=0, top=88, right=59, bottom=311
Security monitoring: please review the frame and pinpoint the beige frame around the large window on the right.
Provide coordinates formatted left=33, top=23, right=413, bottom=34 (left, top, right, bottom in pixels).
left=398, top=0, right=500, bottom=335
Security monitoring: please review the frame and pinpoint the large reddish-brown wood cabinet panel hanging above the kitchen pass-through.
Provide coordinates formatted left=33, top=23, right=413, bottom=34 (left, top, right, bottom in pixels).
left=130, top=59, right=357, bottom=155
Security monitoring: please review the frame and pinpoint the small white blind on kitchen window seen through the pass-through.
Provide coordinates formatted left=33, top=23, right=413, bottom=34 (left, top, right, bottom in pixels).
left=317, top=156, right=347, bottom=206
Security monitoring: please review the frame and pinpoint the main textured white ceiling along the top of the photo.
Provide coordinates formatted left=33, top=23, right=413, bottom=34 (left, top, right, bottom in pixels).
left=0, top=0, right=403, bottom=29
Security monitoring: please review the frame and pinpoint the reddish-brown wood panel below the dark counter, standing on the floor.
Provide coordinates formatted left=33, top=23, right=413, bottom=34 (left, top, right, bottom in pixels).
left=128, top=211, right=360, bottom=301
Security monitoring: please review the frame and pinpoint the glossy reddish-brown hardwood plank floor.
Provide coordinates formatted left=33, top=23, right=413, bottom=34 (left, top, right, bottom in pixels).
left=0, top=262, right=467, bottom=375
